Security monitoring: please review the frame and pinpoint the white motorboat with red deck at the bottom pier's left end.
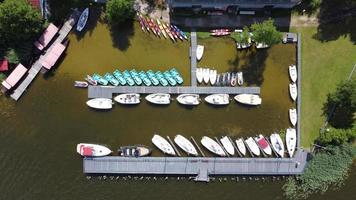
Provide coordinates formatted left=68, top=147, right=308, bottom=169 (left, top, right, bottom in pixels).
left=77, top=143, right=112, bottom=157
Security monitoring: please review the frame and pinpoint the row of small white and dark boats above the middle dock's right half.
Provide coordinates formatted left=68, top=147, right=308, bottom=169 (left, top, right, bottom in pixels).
left=196, top=68, right=244, bottom=87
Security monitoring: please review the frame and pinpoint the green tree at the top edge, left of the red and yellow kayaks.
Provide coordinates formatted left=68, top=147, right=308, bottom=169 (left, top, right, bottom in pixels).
left=106, top=0, right=134, bottom=25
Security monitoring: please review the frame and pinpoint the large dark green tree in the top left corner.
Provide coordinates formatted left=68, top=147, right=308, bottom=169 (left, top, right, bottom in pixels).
left=0, top=0, right=43, bottom=47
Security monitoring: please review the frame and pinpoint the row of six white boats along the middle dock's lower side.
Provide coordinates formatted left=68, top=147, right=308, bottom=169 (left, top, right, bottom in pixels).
left=86, top=93, right=262, bottom=110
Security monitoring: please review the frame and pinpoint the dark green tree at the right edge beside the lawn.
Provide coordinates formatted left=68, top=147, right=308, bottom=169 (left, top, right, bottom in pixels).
left=323, top=79, right=356, bottom=128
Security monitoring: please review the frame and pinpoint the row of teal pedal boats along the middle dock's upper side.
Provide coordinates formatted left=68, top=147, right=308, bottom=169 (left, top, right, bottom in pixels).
left=74, top=68, right=183, bottom=87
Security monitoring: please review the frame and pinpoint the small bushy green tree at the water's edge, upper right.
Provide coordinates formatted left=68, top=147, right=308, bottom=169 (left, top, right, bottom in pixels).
left=251, top=19, right=282, bottom=45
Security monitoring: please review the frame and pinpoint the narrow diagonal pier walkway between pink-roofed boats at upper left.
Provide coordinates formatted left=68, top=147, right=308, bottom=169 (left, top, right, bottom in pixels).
left=10, top=14, right=76, bottom=101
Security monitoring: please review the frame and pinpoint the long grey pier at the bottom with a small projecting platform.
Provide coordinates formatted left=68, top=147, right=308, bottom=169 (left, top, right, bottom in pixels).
left=83, top=150, right=308, bottom=181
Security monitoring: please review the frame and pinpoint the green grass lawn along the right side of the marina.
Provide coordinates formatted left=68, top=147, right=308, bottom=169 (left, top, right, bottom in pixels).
left=293, top=27, right=356, bottom=148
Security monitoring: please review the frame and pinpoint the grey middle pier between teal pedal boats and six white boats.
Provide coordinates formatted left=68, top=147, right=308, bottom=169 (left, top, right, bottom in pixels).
left=88, top=86, right=260, bottom=99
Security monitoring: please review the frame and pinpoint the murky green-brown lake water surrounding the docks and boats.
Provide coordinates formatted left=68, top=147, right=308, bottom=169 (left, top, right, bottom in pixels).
left=0, top=20, right=356, bottom=200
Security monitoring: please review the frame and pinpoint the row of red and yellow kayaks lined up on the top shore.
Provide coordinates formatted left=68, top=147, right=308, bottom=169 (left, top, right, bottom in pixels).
left=137, top=12, right=188, bottom=42
